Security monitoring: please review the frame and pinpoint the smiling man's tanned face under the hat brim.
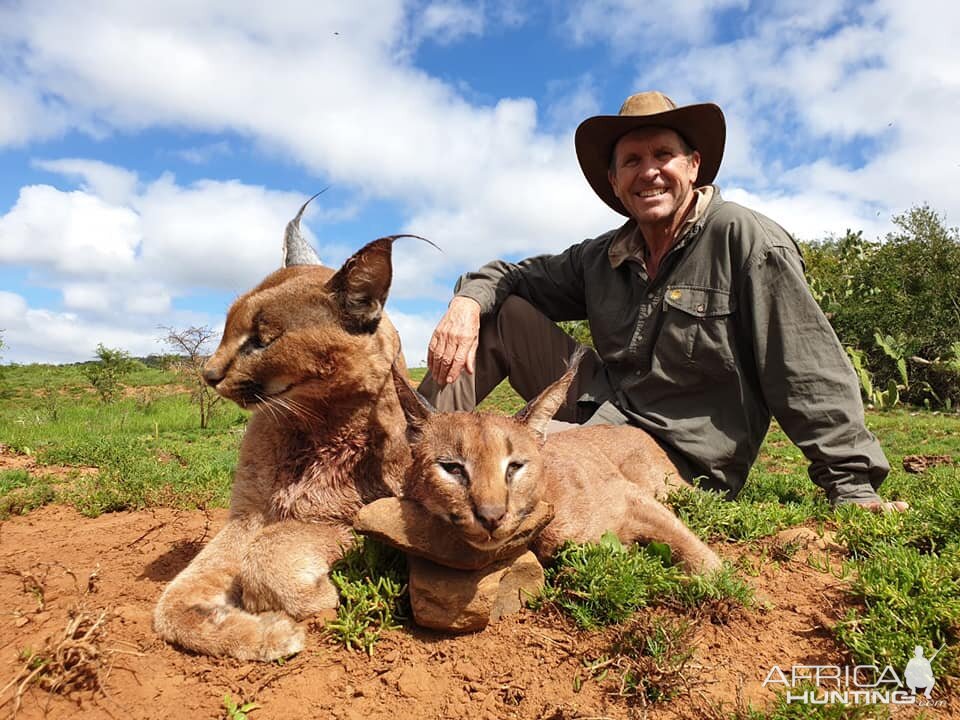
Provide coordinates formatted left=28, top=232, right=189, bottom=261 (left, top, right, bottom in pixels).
left=609, top=127, right=700, bottom=225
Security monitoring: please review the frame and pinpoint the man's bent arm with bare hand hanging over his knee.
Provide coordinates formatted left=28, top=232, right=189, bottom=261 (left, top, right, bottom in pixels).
left=427, top=241, right=589, bottom=384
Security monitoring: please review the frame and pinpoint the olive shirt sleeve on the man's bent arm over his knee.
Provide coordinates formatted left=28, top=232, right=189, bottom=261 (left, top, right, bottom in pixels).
left=454, top=241, right=590, bottom=321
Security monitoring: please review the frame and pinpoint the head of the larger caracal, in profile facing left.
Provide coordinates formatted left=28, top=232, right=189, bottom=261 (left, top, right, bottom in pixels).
left=203, top=193, right=399, bottom=416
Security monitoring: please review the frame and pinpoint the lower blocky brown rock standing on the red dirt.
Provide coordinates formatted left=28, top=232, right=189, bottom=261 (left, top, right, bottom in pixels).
left=409, top=551, right=544, bottom=632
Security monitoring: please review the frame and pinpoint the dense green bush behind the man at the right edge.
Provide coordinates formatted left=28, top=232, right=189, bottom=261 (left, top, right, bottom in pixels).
left=804, top=205, right=960, bottom=405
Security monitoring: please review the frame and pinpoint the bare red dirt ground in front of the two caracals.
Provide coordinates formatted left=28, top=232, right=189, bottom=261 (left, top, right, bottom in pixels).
left=0, top=506, right=956, bottom=720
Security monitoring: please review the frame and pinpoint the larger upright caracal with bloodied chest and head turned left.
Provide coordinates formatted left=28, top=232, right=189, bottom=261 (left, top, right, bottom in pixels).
left=154, top=201, right=410, bottom=660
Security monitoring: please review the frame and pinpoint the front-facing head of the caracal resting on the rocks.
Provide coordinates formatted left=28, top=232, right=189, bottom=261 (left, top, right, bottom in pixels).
left=393, top=353, right=582, bottom=550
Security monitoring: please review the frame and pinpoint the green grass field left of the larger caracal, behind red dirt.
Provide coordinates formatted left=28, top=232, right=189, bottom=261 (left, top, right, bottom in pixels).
left=0, top=366, right=246, bottom=516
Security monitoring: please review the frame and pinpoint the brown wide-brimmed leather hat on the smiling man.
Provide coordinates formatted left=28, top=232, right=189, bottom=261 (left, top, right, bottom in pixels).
left=574, top=90, right=727, bottom=217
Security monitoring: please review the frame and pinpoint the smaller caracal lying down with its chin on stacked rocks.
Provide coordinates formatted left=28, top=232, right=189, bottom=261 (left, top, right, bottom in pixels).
left=394, top=353, right=721, bottom=572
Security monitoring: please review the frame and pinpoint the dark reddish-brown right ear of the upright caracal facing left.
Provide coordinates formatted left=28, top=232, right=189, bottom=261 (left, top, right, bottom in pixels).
left=326, top=235, right=397, bottom=334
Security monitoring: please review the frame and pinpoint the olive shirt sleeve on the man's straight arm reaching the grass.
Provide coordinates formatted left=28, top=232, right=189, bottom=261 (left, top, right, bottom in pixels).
left=742, top=228, right=890, bottom=505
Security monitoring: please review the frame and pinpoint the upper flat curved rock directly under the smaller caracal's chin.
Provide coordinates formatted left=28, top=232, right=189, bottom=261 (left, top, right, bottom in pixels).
left=353, top=498, right=553, bottom=570
